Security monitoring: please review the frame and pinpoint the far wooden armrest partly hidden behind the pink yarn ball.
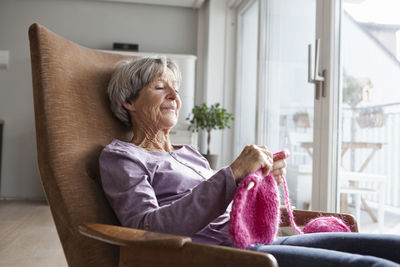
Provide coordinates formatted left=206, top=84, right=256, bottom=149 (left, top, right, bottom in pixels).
left=280, top=207, right=358, bottom=232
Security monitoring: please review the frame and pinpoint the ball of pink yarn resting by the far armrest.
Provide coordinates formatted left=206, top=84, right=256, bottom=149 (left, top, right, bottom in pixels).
left=303, top=217, right=351, bottom=234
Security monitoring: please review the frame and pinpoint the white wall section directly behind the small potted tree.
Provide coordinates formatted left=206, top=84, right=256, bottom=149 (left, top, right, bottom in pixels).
left=196, top=0, right=236, bottom=167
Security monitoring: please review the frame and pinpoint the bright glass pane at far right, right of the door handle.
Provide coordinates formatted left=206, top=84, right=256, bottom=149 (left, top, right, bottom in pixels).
left=338, top=0, right=400, bottom=234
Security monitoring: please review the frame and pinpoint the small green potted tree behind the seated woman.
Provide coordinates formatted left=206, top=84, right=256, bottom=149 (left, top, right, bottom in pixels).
left=186, top=103, right=234, bottom=169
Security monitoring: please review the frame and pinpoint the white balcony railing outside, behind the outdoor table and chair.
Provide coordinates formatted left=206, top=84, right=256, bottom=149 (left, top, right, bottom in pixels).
left=281, top=108, right=400, bottom=211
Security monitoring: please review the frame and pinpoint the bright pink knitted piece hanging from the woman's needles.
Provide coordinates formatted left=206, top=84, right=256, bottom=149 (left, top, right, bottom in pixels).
left=229, top=170, right=280, bottom=248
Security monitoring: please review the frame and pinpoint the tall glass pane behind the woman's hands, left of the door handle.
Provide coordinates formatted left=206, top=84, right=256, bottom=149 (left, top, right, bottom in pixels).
left=257, top=0, right=316, bottom=209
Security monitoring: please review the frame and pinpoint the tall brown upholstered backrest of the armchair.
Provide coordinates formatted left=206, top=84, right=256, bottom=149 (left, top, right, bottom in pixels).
left=29, top=24, right=134, bottom=267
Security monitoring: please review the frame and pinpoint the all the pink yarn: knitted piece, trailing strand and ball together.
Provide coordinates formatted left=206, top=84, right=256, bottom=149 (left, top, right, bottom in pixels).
left=229, top=152, right=351, bottom=248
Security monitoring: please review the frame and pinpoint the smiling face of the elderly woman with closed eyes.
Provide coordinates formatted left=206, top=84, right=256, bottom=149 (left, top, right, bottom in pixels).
left=131, top=69, right=181, bottom=130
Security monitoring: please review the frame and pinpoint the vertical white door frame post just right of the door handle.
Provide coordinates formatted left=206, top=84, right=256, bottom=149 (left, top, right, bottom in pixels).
left=312, top=0, right=341, bottom=212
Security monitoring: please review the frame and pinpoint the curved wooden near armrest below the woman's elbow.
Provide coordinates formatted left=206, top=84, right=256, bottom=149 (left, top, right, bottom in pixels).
left=79, top=223, right=191, bottom=248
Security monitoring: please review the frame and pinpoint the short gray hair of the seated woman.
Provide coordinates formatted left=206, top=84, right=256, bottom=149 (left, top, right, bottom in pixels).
left=107, top=56, right=182, bottom=127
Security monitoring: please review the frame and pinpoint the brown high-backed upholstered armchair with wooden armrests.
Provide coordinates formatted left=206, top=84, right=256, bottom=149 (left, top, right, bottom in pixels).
left=29, top=24, right=357, bottom=267
